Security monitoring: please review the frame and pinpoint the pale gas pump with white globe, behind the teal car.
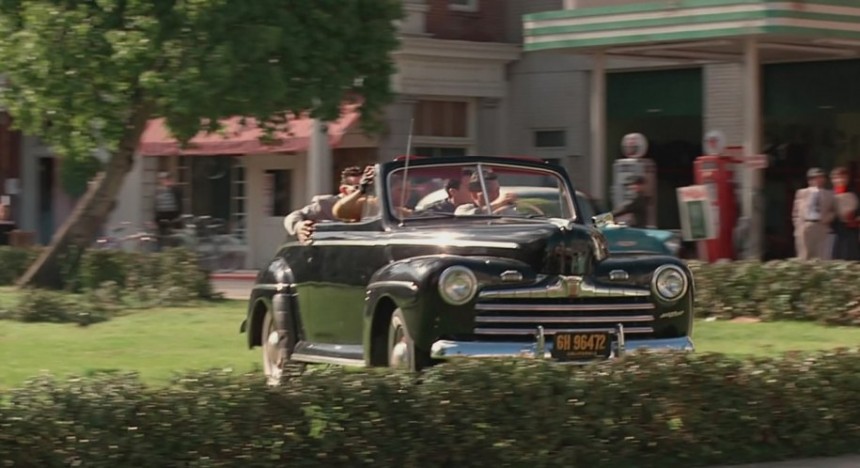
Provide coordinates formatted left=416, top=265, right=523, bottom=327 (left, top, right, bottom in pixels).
left=612, top=133, right=657, bottom=228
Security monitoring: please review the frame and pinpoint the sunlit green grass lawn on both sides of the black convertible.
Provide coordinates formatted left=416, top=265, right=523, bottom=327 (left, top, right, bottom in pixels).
left=0, top=288, right=860, bottom=388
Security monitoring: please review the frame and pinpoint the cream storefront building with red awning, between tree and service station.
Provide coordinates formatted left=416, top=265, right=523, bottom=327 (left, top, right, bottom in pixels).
left=117, top=0, right=521, bottom=269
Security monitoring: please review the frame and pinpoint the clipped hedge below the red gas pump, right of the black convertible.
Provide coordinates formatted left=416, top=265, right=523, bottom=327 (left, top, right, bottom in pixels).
left=690, top=260, right=860, bottom=326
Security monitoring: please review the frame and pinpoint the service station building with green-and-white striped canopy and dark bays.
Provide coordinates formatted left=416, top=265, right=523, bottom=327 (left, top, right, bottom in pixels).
left=523, top=0, right=860, bottom=258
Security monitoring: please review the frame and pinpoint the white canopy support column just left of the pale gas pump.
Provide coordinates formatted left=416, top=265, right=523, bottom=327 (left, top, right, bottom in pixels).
left=589, top=52, right=608, bottom=206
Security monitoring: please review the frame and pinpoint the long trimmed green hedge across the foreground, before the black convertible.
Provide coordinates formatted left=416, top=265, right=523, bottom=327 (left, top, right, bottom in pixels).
left=0, top=350, right=860, bottom=468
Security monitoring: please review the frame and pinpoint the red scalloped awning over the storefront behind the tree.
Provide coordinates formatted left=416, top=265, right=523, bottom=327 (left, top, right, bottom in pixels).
left=137, top=104, right=359, bottom=156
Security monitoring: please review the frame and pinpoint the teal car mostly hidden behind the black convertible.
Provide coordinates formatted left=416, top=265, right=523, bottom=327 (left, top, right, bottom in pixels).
left=415, top=186, right=681, bottom=257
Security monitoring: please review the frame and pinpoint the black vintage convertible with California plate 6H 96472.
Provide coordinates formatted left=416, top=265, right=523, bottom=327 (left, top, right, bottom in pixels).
left=240, top=157, right=694, bottom=383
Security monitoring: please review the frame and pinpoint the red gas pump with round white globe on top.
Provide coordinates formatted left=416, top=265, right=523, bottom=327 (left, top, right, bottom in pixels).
left=693, top=131, right=739, bottom=262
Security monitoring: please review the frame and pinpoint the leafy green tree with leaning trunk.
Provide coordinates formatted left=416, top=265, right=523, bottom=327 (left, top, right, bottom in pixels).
left=0, top=0, right=402, bottom=287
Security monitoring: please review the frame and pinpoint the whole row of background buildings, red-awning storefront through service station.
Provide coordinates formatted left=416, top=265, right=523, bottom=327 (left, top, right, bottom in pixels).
left=11, top=0, right=860, bottom=268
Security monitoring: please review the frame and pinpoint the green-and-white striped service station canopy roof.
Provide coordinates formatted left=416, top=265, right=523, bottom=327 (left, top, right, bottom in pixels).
left=524, top=0, right=860, bottom=64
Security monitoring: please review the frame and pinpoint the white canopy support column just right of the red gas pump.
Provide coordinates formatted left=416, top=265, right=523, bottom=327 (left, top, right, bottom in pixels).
left=741, top=37, right=764, bottom=259
